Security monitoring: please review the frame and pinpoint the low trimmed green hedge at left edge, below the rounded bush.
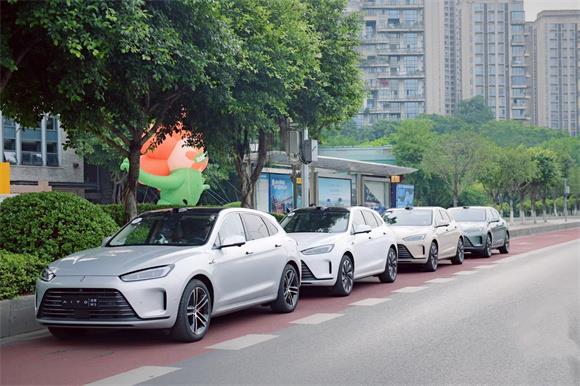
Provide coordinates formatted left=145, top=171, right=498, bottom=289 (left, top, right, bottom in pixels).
left=0, top=249, right=46, bottom=300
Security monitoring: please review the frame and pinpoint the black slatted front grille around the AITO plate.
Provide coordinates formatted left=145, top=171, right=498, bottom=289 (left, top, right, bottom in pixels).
left=38, top=288, right=139, bottom=322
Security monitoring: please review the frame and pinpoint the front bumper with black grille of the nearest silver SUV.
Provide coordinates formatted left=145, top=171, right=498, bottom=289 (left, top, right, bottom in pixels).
left=35, top=275, right=182, bottom=328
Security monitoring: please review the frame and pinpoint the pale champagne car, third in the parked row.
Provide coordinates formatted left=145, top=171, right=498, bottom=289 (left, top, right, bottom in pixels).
left=384, top=207, right=465, bottom=272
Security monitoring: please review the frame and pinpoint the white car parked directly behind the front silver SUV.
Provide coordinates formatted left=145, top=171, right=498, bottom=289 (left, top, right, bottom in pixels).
left=282, top=207, right=397, bottom=296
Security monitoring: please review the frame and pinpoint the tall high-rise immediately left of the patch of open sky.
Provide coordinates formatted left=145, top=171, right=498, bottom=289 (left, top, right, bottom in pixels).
left=459, top=0, right=529, bottom=120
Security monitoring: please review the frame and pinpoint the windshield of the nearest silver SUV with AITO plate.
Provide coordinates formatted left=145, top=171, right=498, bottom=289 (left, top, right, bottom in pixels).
left=107, top=212, right=217, bottom=247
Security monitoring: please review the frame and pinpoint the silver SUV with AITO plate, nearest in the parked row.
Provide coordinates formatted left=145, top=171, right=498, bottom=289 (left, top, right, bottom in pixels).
left=36, top=208, right=300, bottom=342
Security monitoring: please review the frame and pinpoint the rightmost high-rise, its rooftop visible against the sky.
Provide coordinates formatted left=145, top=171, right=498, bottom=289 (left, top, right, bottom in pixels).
left=526, top=10, right=580, bottom=136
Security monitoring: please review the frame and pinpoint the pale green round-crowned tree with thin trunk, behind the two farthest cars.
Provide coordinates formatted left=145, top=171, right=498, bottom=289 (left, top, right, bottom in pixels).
left=421, top=131, right=485, bottom=206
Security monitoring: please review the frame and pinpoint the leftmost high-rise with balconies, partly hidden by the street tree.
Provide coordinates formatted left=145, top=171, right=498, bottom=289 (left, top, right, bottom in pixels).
left=349, top=0, right=425, bottom=125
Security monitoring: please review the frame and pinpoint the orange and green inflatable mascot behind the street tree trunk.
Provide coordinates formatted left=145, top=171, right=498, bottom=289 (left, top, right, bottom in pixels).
left=121, top=133, right=209, bottom=206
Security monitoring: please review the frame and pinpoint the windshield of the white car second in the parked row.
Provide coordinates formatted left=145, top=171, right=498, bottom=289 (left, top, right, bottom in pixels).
left=282, top=210, right=349, bottom=233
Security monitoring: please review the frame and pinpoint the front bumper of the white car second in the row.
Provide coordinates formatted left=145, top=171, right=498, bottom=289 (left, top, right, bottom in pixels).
left=300, top=252, right=342, bottom=287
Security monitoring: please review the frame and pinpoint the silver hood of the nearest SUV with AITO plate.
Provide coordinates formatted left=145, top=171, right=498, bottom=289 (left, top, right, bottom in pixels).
left=50, top=245, right=201, bottom=276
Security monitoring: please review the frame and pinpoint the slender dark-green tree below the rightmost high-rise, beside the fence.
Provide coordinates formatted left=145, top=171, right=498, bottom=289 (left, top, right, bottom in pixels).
left=529, top=147, right=560, bottom=224
